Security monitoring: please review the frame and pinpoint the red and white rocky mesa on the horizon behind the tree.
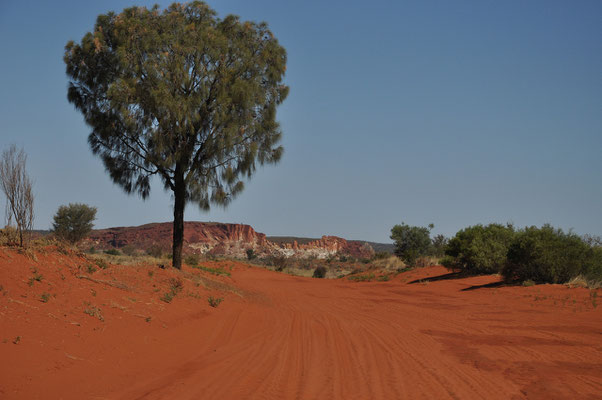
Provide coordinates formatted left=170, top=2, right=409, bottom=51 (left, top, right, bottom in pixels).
left=85, top=222, right=374, bottom=258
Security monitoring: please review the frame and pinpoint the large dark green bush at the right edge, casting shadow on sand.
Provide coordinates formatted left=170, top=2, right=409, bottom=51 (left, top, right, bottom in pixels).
left=503, top=225, right=602, bottom=283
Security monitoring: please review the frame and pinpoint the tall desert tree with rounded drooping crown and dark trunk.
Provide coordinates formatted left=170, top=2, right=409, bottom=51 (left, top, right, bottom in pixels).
left=64, top=1, right=288, bottom=268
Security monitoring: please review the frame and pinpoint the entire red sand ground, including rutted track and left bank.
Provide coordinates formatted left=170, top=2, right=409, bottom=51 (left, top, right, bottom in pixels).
left=0, top=248, right=602, bottom=400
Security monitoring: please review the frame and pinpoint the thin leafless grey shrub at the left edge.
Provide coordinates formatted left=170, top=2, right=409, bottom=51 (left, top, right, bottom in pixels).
left=0, top=145, right=34, bottom=247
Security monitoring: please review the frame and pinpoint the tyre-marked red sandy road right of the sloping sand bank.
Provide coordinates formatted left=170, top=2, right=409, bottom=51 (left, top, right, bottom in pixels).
left=115, top=268, right=602, bottom=399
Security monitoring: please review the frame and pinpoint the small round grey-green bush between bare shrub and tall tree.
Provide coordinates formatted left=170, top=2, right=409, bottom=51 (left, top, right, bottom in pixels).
left=52, top=203, right=96, bottom=244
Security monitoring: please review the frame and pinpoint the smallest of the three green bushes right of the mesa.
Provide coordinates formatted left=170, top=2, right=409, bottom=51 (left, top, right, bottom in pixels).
left=391, top=223, right=433, bottom=266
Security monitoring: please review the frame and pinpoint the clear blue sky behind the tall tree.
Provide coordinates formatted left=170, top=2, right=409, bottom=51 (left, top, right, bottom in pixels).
left=0, top=0, right=602, bottom=242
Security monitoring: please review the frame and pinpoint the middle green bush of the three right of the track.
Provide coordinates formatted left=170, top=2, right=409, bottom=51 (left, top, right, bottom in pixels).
left=441, top=224, right=515, bottom=274
